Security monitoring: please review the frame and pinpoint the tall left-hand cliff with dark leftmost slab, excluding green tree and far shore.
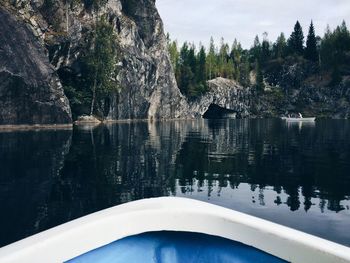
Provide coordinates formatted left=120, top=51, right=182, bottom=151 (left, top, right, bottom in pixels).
left=0, top=0, right=188, bottom=124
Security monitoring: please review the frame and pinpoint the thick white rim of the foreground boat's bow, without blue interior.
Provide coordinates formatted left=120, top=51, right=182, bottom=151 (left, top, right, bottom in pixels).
left=0, top=197, right=350, bottom=263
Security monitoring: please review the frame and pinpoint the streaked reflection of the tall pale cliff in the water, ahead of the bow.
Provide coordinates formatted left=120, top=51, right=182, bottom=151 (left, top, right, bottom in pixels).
left=34, top=122, right=189, bottom=232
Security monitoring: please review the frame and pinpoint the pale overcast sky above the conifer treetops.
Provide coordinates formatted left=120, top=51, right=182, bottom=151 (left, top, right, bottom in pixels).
left=156, top=0, right=350, bottom=48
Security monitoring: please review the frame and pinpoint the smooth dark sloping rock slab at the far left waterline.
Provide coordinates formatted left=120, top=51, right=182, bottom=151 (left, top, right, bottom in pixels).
left=0, top=7, right=72, bottom=125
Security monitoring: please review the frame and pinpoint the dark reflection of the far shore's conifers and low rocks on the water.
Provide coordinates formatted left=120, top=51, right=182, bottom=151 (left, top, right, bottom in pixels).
left=176, top=120, right=350, bottom=211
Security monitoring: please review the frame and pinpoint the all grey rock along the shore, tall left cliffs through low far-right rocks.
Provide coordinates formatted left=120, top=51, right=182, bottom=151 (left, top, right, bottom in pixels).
left=0, top=0, right=350, bottom=124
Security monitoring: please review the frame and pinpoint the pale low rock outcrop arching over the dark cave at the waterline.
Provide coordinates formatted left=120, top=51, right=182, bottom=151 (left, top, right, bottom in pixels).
left=189, top=78, right=251, bottom=118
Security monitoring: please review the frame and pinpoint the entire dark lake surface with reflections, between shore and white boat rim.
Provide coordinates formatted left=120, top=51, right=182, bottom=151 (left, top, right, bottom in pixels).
left=0, top=119, right=350, bottom=249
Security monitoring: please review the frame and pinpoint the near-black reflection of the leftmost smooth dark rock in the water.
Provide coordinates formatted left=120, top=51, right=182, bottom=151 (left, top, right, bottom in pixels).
left=0, top=130, right=72, bottom=249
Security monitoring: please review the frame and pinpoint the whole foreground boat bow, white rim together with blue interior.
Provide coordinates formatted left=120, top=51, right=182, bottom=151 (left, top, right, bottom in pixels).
left=0, top=197, right=350, bottom=263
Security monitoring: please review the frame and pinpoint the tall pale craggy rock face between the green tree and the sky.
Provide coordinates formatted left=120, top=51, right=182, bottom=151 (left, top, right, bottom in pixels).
left=108, top=0, right=188, bottom=119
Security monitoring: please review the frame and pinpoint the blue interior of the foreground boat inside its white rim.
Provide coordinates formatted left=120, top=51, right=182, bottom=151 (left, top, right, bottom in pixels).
left=68, top=231, right=286, bottom=263
